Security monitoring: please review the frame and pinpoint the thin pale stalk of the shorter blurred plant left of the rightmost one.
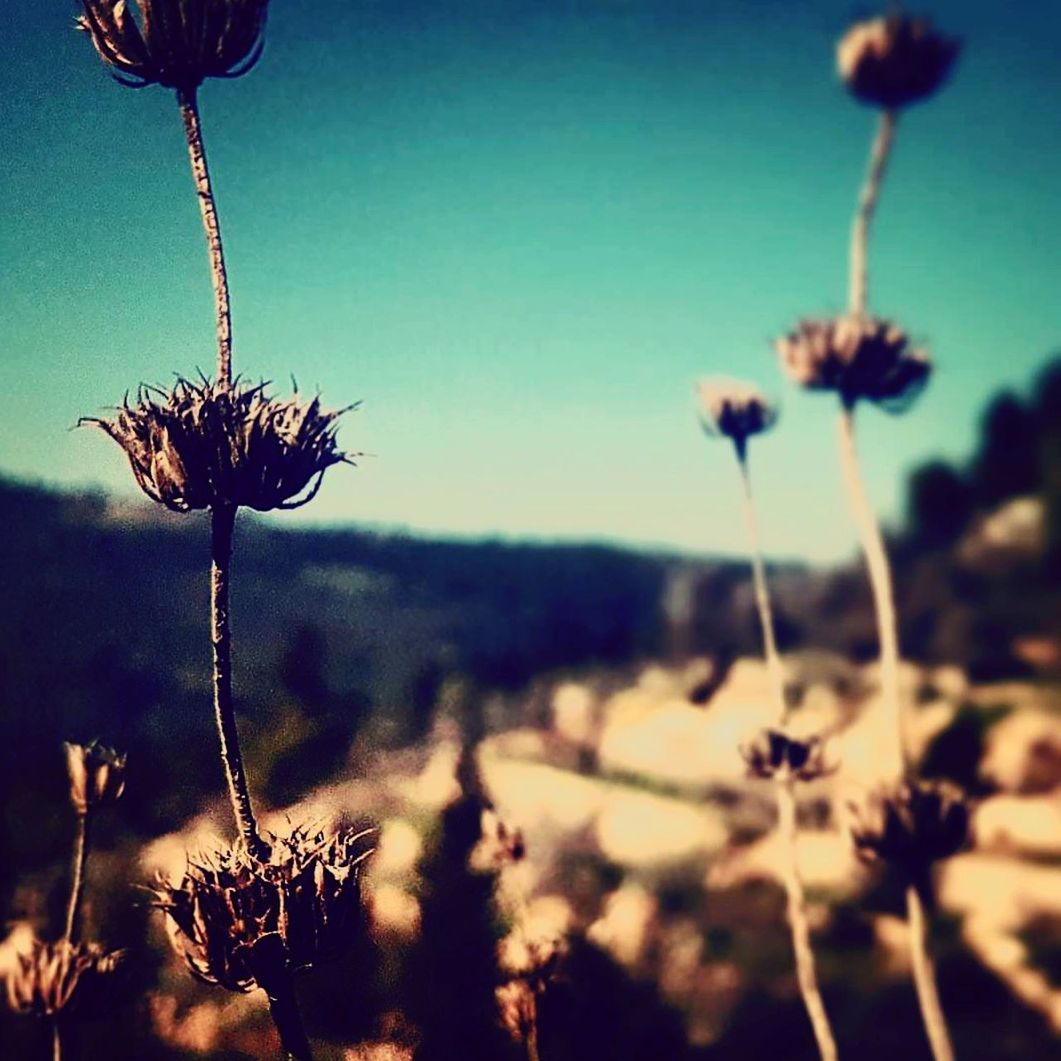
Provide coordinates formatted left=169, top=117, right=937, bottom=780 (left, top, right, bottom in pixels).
left=736, top=442, right=838, bottom=1061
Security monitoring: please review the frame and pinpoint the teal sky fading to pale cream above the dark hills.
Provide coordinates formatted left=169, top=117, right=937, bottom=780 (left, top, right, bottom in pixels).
left=0, top=0, right=1061, bottom=559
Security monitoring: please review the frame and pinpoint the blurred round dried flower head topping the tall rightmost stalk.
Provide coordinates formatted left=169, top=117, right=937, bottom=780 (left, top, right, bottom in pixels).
left=836, top=15, right=960, bottom=109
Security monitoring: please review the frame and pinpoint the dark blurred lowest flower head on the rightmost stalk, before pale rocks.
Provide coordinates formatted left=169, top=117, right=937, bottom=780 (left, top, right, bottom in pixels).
left=850, top=781, right=969, bottom=872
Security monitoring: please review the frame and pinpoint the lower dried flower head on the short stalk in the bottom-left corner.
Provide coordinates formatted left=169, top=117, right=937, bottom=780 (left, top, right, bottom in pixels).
left=7, top=939, right=125, bottom=1016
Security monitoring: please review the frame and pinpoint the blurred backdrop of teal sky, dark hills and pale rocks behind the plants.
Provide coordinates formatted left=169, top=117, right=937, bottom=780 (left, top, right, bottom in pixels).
left=0, top=0, right=1061, bottom=1061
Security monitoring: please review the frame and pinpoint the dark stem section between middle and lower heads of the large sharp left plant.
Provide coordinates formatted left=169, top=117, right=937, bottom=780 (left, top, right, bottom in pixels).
left=210, top=505, right=268, bottom=862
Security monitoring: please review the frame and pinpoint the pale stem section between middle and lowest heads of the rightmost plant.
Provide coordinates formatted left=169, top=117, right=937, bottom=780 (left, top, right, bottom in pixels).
left=838, top=405, right=907, bottom=779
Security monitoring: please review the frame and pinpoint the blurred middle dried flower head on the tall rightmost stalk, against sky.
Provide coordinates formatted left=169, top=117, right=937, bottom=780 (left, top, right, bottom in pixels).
left=775, top=314, right=932, bottom=413
